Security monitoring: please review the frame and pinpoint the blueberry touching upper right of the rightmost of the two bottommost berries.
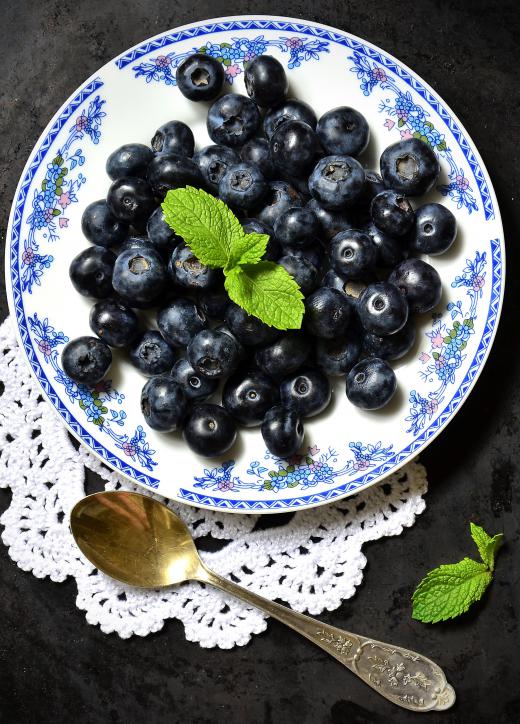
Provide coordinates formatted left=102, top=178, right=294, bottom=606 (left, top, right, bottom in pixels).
left=280, top=368, right=332, bottom=418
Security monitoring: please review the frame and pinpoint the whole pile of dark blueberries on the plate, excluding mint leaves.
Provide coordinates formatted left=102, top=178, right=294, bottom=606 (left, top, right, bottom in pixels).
left=62, top=54, right=456, bottom=457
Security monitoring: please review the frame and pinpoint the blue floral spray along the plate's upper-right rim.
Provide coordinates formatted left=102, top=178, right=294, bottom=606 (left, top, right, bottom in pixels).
left=349, top=51, right=478, bottom=214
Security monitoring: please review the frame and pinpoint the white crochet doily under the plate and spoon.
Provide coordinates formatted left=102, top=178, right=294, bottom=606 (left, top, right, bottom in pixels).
left=0, top=319, right=427, bottom=648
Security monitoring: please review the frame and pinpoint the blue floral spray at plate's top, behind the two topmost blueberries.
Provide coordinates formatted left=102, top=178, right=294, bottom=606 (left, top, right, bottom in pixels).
left=133, top=35, right=329, bottom=85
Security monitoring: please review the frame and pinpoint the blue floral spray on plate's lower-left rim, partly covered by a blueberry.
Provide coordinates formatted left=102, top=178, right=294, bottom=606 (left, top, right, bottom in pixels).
left=28, top=314, right=157, bottom=470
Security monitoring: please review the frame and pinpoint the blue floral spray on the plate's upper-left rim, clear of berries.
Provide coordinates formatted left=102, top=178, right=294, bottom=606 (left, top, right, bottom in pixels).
left=21, top=96, right=106, bottom=294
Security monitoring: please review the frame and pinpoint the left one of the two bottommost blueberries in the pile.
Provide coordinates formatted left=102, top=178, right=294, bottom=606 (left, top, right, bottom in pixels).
left=183, top=402, right=237, bottom=457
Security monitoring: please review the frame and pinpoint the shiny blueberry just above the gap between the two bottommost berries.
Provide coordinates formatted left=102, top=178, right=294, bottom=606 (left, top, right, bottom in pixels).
left=222, top=369, right=279, bottom=427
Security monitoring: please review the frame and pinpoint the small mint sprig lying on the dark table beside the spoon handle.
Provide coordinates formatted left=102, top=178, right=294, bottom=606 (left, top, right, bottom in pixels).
left=412, top=523, right=504, bottom=623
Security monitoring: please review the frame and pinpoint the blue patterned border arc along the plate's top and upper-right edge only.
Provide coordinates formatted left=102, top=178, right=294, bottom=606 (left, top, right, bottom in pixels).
left=115, top=19, right=495, bottom=220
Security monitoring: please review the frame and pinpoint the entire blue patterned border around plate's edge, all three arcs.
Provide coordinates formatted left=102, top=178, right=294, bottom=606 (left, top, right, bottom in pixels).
left=10, top=20, right=502, bottom=511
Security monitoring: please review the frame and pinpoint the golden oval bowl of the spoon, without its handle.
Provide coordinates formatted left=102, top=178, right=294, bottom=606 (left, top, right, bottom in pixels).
left=70, top=491, right=202, bottom=588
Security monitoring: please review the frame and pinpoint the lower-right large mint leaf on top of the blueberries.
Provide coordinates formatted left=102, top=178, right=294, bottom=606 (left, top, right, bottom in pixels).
left=225, top=261, right=305, bottom=329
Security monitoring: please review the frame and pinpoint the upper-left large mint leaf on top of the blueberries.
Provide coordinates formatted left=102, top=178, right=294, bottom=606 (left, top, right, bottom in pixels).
left=162, top=186, right=245, bottom=268
